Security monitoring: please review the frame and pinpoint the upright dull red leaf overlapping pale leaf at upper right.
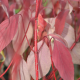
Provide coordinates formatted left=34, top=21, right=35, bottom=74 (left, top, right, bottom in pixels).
left=55, top=10, right=69, bottom=35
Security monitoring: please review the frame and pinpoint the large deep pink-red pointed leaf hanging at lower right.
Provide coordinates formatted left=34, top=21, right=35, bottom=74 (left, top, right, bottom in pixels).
left=52, top=40, right=74, bottom=80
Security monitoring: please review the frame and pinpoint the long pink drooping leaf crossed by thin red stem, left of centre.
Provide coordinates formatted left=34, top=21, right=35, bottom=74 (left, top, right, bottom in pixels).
left=12, top=10, right=33, bottom=54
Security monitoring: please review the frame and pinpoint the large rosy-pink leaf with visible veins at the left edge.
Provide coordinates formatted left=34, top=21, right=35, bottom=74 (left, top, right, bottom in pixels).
left=0, top=15, right=19, bottom=51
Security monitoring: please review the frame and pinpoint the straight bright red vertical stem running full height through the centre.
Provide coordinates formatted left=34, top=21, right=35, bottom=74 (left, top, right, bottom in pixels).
left=34, top=0, right=41, bottom=80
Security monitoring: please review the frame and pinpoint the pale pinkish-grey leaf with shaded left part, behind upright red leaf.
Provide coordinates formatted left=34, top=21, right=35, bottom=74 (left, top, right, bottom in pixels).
left=61, top=23, right=75, bottom=48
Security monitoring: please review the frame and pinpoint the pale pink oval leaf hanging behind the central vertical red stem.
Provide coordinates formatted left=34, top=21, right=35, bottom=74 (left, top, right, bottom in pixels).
left=27, top=41, right=51, bottom=79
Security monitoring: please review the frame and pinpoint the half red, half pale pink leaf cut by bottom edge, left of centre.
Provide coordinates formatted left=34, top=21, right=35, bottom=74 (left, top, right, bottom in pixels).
left=12, top=55, right=30, bottom=80
